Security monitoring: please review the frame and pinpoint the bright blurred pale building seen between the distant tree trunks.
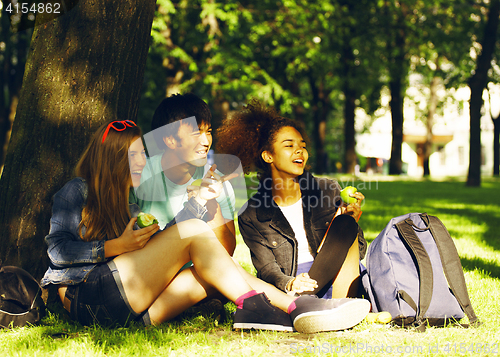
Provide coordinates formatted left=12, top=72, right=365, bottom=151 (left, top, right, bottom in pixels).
left=356, top=84, right=498, bottom=177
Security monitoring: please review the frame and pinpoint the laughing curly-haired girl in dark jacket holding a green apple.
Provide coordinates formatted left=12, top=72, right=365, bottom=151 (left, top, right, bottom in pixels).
left=218, top=100, right=366, bottom=298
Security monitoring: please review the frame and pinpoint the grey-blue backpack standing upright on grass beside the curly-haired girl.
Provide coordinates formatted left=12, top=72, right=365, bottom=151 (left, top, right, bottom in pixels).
left=362, top=213, right=480, bottom=331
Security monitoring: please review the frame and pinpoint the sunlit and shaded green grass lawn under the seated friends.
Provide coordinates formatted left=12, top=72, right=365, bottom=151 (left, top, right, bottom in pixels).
left=0, top=177, right=500, bottom=357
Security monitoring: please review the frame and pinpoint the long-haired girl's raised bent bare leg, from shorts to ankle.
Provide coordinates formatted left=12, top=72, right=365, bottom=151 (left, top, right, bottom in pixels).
left=114, top=220, right=252, bottom=313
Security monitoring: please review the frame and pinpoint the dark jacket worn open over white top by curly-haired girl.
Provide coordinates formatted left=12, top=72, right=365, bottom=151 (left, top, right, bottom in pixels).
left=238, top=171, right=366, bottom=291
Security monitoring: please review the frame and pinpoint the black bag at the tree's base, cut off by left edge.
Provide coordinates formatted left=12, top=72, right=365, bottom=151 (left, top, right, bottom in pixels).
left=0, top=261, right=45, bottom=328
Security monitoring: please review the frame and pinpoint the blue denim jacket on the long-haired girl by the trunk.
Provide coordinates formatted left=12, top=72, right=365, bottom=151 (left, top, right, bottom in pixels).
left=41, top=177, right=207, bottom=287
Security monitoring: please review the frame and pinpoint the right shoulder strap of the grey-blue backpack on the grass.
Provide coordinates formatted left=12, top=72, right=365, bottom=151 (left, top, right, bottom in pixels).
left=420, top=213, right=481, bottom=326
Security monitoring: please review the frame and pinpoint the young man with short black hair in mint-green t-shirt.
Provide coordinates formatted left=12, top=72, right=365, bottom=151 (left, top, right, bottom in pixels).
left=137, top=94, right=241, bottom=255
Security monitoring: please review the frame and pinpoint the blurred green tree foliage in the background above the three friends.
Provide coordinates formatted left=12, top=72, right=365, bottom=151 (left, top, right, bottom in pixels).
left=135, top=0, right=496, bottom=178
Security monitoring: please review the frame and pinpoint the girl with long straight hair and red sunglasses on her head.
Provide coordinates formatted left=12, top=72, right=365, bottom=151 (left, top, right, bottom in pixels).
left=42, top=120, right=370, bottom=333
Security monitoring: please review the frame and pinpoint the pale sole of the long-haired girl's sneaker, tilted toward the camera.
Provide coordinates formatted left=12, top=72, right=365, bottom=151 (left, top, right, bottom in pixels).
left=293, top=299, right=371, bottom=333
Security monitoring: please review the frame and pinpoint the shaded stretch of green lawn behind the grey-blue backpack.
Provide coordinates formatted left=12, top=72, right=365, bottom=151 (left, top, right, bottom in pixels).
left=360, top=180, right=500, bottom=279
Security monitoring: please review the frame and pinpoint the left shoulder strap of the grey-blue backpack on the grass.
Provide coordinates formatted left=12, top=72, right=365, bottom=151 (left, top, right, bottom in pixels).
left=396, top=217, right=434, bottom=331
